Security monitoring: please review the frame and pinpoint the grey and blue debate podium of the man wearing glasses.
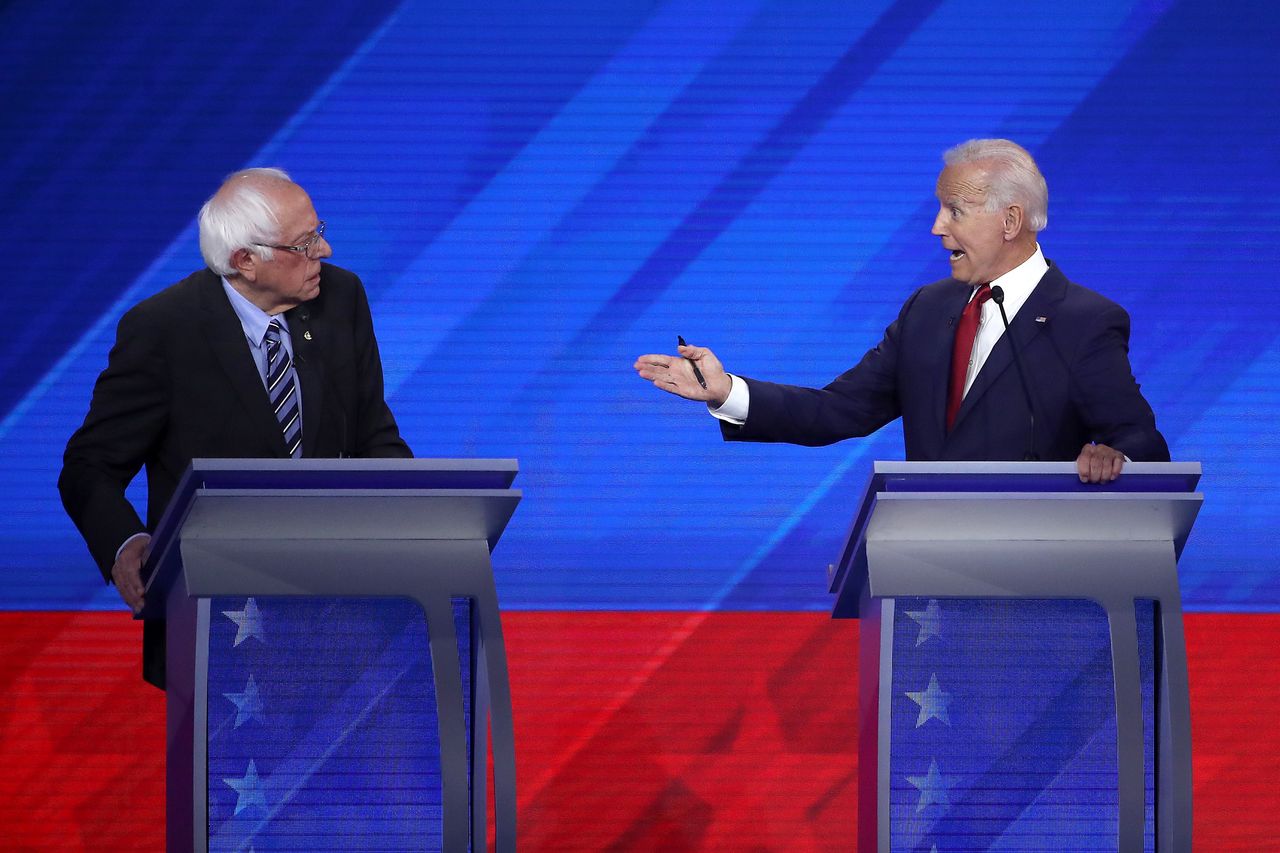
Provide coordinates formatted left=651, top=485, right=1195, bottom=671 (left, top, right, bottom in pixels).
left=141, top=460, right=521, bottom=853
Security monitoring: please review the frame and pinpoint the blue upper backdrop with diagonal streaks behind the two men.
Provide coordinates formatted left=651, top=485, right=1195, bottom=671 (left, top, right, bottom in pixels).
left=0, top=0, right=1280, bottom=610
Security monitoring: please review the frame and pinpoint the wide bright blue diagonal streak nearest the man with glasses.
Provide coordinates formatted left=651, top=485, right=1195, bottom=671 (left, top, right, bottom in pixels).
left=375, top=0, right=759, bottom=396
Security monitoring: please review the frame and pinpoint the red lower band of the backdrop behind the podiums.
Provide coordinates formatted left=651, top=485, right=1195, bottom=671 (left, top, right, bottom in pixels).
left=0, top=612, right=1280, bottom=852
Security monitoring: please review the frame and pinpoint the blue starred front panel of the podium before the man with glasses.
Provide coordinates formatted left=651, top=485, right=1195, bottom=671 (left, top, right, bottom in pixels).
left=207, top=597, right=471, bottom=852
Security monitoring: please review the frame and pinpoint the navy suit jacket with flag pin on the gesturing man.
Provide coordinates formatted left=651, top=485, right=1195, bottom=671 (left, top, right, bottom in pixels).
left=722, top=264, right=1169, bottom=461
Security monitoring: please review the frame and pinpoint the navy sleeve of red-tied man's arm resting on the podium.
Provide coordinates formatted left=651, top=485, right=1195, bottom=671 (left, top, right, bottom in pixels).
left=1071, top=298, right=1169, bottom=462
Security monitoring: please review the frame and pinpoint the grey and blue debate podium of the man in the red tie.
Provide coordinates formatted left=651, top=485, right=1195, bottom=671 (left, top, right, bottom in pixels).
left=832, top=462, right=1203, bottom=853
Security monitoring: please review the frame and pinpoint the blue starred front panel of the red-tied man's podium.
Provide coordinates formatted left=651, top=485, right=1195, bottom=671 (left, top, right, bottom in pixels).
left=890, top=598, right=1156, bottom=853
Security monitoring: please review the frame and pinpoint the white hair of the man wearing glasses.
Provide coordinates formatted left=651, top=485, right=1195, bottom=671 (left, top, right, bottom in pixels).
left=198, top=168, right=293, bottom=275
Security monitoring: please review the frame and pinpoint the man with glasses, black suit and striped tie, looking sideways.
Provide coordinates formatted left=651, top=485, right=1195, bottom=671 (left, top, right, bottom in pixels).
left=58, top=169, right=412, bottom=686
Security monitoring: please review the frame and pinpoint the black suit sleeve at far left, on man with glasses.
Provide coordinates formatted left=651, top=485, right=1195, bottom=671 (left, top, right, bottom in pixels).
left=58, top=302, right=168, bottom=579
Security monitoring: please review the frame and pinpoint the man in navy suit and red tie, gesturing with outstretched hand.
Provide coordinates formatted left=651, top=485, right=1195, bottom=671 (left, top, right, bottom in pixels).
left=635, top=140, right=1169, bottom=473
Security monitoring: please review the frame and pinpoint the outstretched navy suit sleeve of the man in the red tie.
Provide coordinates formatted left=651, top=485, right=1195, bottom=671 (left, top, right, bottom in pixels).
left=721, top=291, right=919, bottom=447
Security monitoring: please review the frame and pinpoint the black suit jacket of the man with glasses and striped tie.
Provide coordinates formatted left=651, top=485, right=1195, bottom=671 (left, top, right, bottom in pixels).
left=58, top=264, right=412, bottom=686
